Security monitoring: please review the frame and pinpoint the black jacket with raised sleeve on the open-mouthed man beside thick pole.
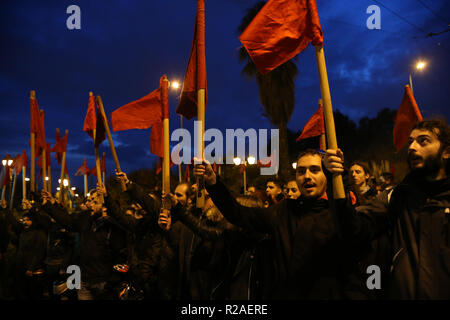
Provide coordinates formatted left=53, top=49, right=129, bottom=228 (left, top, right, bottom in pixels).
left=207, top=181, right=354, bottom=299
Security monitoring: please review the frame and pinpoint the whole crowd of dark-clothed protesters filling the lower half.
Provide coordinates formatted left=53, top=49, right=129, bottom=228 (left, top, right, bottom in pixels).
left=0, top=121, right=450, bottom=300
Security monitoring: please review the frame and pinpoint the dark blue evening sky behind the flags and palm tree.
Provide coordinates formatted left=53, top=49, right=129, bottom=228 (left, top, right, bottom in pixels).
left=0, top=0, right=450, bottom=190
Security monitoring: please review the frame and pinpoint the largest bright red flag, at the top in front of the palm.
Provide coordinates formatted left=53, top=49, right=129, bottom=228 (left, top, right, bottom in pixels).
left=239, top=0, right=323, bottom=74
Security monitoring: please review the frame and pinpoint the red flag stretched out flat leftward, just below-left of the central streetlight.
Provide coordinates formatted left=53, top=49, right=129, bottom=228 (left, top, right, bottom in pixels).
left=111, top=88, right=162, bottom=131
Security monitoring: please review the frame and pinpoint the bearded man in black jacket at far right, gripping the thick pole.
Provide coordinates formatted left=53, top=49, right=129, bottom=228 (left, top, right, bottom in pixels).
left=325, top=120, right=450, bottom=299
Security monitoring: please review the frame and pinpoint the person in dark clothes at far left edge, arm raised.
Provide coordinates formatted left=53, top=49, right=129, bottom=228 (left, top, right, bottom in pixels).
left=2, top=201, right=47, bottom=300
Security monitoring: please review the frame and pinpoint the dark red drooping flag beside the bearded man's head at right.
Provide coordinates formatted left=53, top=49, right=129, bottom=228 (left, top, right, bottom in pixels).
left=393, top=85, right=423, bottom=151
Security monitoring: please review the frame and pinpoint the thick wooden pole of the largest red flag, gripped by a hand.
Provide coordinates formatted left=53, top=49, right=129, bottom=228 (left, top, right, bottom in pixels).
left=315, top=46, right=345, bottom=199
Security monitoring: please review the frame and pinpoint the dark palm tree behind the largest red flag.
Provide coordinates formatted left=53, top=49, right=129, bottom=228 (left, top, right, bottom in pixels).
left=238, top=1, right=298, bottom=178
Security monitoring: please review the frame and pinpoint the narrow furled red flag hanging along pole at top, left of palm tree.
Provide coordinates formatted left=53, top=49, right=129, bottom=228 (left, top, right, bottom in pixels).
left=176, top=0, right=208, bottom=119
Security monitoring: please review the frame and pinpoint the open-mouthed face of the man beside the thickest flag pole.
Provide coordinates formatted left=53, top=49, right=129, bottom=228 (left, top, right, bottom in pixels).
left=296, top=154, right=327, bottom=198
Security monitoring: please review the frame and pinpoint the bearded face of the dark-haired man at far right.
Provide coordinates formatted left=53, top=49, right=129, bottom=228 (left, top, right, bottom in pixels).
left=408, top=129, right=449, bottom=174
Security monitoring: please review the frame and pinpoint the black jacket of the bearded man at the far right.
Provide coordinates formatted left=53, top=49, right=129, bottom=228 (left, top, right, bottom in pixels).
left=340, top=174, right=450, bottom=299
